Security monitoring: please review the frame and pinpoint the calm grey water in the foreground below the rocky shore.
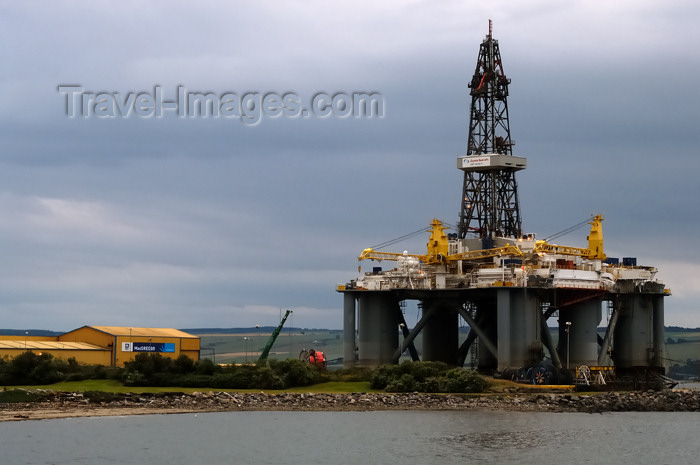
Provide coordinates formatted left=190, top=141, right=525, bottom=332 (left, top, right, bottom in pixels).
left=0, top=412, right=700, bottom=465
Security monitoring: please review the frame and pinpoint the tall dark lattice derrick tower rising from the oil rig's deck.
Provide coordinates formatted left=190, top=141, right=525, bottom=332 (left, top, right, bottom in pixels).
left=457, top=20, right=527, bottom=240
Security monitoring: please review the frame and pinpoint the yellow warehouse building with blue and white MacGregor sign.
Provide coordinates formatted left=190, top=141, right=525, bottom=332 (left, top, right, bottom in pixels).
left=0, top=326, right=200, bottom=366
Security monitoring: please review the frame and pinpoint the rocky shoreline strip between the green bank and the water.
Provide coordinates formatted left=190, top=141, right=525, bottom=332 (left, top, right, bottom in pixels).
left=0, top=390, right=700, bottom=421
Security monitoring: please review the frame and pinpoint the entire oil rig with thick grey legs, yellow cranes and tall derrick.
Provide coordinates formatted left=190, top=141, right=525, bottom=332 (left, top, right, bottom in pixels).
left=337, top=21, right=670, bottom=384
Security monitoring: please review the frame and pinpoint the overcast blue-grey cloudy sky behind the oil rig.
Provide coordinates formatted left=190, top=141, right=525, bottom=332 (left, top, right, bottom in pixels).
left=0, top=0, right=700, bottom=331
